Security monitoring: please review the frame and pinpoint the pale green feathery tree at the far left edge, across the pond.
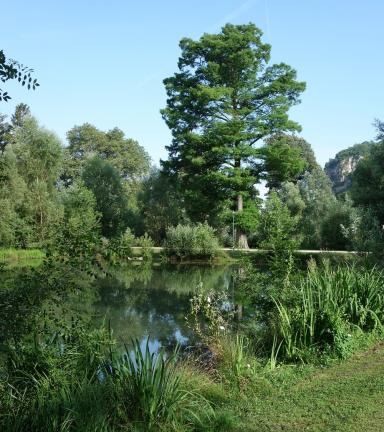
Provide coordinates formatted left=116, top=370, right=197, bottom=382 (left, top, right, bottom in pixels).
left=0, top=113, right=63, bottom=248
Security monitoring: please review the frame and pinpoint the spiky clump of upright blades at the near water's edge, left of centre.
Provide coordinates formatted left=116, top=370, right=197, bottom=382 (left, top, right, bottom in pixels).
left=103, top=338, right=213, bottom=429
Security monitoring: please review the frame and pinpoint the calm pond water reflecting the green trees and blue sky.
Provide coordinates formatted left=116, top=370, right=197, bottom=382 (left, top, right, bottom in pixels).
left=2, top=261, right=242, bottom=352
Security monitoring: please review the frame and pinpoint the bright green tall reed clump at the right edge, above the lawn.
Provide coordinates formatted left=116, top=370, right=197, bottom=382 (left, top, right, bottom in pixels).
left=275, top=262, right=384, bottom=360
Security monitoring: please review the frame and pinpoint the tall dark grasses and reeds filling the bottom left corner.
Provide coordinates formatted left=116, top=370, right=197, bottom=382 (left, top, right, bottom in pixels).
left=0, top=329, right=213, bottom=432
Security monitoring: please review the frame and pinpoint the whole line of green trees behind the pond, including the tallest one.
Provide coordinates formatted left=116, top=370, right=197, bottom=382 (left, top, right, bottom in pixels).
left=0, top=23, right=384, bottom=253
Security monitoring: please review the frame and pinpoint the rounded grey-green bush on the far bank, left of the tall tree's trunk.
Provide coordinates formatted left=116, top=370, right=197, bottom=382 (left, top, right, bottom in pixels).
left=164, top=223, right=219, bottom=259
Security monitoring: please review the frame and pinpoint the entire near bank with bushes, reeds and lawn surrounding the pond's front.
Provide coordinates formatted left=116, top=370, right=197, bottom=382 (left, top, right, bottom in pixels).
left=0, top=238, right=384, bottom=432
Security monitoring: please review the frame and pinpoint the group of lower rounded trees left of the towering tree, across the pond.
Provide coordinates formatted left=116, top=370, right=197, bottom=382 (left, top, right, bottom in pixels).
left=0, top=104, right=150, bottom=247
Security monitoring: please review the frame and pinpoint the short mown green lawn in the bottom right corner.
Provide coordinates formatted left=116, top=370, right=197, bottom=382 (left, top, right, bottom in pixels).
left=234, top=342, right=384, bottom=432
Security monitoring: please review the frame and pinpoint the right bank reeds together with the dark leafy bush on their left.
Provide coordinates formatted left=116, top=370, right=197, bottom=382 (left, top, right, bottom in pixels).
left=240, top=260, right=384, bottom=362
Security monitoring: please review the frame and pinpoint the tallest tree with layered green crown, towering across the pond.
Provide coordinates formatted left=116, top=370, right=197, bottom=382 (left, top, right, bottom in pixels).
left=161, top=23, right=305, bottom=247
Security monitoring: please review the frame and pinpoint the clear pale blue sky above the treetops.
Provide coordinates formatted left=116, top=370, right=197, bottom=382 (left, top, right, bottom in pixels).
left=0, top=0, right=384, bottom=166
